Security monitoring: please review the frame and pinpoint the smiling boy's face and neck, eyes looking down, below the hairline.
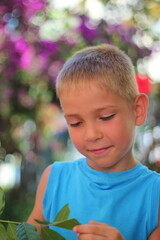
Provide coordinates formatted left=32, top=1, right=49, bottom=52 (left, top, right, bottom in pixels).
left=60, top=84, right=139, bottom=172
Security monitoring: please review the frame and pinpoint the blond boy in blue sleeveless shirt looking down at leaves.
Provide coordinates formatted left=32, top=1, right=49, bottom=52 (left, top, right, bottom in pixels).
left=28, top=44, right=160, bottom=240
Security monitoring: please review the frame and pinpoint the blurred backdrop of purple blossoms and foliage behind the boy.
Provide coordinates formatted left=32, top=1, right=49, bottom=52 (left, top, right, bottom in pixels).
left=0, top=0, right=160, bottom=221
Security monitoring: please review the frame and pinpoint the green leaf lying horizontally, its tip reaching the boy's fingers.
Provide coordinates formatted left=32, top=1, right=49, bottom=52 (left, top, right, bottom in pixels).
left=50, top=218, right=80, bottom=230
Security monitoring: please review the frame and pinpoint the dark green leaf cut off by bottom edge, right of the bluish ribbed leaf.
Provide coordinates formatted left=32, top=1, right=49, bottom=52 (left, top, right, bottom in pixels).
left=41, top=228, right=65, bottom=240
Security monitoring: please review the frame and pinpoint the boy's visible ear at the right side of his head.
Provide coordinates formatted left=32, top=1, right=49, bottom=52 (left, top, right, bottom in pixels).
left=134, top=93, right=148, bottom=126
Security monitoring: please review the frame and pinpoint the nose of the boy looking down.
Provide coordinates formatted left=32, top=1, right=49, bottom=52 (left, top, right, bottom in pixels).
left=84, top=125, right=103, bottom=141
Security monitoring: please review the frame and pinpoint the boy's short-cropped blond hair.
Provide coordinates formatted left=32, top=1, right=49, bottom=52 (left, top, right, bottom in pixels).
left=56, top=44, right=138, bottom=100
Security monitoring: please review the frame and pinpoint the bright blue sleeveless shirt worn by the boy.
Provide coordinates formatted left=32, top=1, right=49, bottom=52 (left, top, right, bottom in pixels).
left=43, top=158, right=160, bottom=240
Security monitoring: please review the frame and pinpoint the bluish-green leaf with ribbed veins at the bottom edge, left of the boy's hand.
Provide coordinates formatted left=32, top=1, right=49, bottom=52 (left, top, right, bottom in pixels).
left=16, top=222, right=41, bottom=240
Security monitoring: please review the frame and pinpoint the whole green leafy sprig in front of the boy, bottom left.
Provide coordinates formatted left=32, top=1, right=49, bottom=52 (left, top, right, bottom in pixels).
left=0, top=188, right=80, bottom=240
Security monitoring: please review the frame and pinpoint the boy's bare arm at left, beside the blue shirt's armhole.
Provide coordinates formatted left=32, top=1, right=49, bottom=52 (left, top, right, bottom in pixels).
left=27, top=165, right=52, bottom=231
